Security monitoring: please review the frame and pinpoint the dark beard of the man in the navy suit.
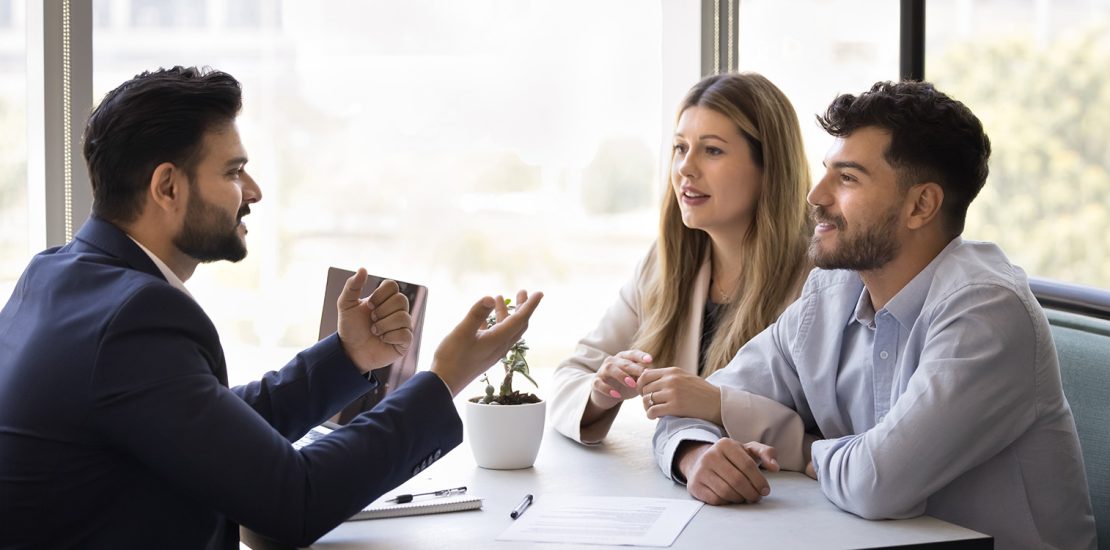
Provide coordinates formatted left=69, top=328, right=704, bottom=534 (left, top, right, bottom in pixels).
left=173, top=186, right=251, bottom=263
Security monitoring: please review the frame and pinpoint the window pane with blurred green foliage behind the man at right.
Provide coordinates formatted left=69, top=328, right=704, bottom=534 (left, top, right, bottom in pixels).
left=926, top=0, right=1110, bottom=288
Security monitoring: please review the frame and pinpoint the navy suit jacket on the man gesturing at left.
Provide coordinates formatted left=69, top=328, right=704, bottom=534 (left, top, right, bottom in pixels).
left=0, top=218, right=462, bottom=548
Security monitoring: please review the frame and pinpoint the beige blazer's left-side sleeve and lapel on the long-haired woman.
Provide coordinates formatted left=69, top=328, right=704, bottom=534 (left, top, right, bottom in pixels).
left=548, top=252, right=712, bottom=444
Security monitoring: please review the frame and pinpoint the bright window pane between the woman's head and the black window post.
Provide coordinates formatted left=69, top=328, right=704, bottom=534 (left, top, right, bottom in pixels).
left=738, top=0, right=899, bottom=177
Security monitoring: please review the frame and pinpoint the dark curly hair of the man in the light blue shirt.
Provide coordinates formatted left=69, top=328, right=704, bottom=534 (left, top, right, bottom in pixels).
left=817, top=81, right=990, bottom=236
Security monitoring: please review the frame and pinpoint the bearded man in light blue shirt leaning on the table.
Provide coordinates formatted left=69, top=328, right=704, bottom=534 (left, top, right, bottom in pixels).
left=643, top=82, right=1096, bottom=548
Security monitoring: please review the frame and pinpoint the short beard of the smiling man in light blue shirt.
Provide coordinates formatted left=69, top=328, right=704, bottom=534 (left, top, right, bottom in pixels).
left=809, top=204, right=901, bottom=271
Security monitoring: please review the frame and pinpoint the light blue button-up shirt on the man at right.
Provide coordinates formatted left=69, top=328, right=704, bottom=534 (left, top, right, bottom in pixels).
left=655, top=238, right=1096, bottom=549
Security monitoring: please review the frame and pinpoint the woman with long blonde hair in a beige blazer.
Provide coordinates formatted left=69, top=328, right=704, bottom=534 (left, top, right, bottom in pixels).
left=551, top=72, right=810, bottom=443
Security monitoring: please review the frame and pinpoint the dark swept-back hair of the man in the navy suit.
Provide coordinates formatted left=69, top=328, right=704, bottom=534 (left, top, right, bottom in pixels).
left=84, top=67, right=243, bottom=223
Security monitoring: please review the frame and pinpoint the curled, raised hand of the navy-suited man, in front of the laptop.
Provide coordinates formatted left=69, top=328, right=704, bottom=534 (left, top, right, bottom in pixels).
left=335, top=268, right=413, bottom=372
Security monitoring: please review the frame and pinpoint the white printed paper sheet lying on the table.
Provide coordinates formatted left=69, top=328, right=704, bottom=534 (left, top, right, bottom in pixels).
left=497, top=494, right=702, bottom=547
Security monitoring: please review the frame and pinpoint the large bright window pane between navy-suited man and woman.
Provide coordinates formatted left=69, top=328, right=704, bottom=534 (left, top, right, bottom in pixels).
left=93, top=0, right=666, bottom=380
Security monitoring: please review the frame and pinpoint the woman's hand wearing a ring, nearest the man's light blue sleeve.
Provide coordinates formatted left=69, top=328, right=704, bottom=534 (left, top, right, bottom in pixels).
left=639, top=367, right=722, bottom=426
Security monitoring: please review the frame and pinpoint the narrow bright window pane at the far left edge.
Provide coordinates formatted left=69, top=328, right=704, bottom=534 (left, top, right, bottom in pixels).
left=0, top=0, right=29, bottom=301
